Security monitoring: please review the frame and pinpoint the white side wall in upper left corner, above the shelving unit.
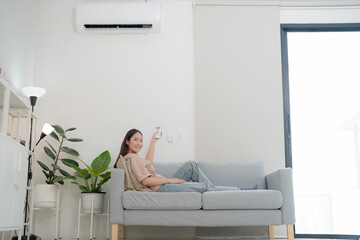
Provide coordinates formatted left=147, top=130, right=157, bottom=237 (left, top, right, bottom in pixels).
left=0, top=0, right=38, bottom=89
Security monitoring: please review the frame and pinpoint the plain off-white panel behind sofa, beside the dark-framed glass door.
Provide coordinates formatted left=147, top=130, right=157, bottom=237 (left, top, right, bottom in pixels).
left=195, top=5, right=285, bottom=172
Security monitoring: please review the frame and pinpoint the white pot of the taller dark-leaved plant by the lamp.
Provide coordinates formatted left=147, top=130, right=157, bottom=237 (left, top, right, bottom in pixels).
left=34, top=184, right=57, bottom=208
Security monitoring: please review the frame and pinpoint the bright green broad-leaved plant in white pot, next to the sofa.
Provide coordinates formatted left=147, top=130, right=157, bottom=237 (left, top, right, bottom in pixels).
left=65, top=150, right=111, bottom=213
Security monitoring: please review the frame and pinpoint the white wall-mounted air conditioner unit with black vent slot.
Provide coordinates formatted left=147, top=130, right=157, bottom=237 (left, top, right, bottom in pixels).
left=76, top=2, right=160, bottom=33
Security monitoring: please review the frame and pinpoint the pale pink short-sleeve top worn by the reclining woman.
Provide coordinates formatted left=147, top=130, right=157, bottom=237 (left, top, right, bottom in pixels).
left=124, top=153, right=164, bottom=192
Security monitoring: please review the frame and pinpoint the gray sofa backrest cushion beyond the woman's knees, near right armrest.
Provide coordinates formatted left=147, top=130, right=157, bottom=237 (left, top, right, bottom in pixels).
left=198, top=162, right=266, bottom=189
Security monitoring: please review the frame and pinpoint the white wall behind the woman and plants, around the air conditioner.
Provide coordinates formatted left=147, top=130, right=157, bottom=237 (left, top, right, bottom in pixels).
left=35, top=0, right=195, bottom=238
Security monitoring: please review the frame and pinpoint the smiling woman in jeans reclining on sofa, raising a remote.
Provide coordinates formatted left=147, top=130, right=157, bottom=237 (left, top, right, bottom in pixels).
left=114, top=129, right=257, bottom=193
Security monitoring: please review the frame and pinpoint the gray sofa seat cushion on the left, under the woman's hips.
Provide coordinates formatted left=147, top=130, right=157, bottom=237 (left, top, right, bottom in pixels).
left=122, top=191, right=202, bottom=210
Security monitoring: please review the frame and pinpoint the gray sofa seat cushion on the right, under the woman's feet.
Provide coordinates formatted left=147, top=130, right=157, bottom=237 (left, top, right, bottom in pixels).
left=202, top=190, right=283, bottom=209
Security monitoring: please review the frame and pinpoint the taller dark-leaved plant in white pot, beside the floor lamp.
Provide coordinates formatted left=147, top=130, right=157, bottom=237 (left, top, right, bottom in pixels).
left=34, top=125, right=83, bottom=208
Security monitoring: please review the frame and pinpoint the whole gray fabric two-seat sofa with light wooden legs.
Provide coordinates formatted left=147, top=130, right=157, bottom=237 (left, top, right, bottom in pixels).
left=110, top=162, right=295, bottom=240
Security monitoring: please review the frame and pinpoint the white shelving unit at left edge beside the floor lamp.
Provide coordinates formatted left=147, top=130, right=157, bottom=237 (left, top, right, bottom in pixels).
left=0, top=77, right=31, bottom=235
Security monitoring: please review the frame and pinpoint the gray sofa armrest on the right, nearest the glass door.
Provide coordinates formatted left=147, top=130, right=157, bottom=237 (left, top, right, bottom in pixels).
left=266, top=168, right=295, bottom=224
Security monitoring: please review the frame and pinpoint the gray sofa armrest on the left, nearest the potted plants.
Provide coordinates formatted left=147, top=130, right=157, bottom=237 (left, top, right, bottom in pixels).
left=110, top=168, right=125, bottom=224
